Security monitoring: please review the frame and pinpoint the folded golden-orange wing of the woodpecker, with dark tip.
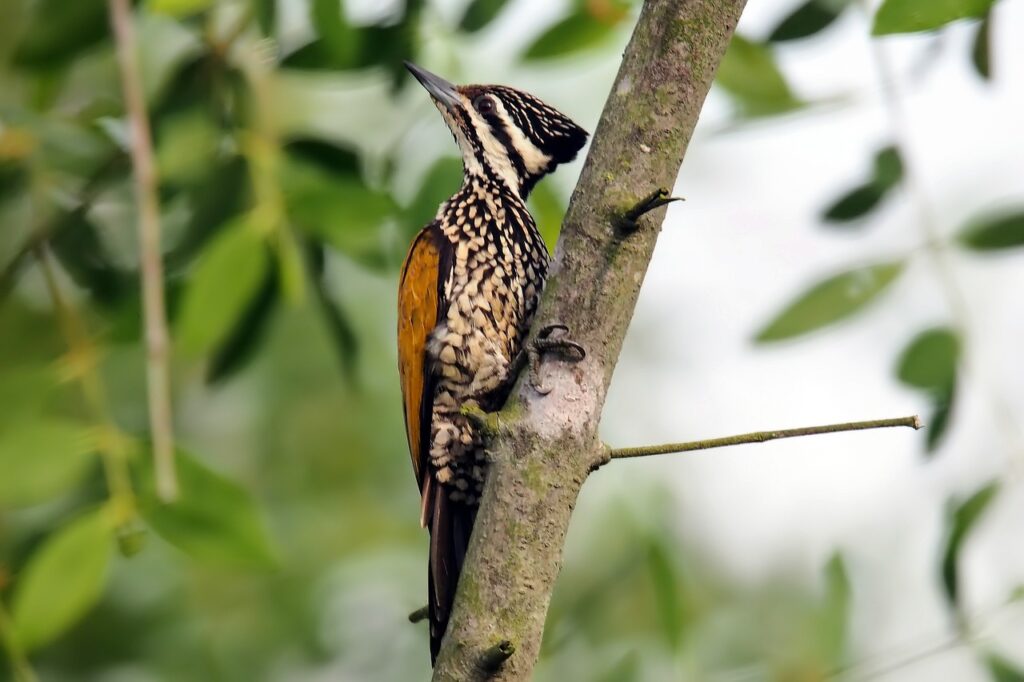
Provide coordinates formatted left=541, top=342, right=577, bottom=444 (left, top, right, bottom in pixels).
left=398, top=223, right=451, bottom=489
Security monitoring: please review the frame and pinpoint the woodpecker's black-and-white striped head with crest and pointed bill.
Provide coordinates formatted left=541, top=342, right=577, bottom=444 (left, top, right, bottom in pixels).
left=406, top=61, right=587, bottom=198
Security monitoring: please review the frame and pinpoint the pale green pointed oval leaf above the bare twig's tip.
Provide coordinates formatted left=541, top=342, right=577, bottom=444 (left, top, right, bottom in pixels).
left=756, top=261, right=903, bottom=343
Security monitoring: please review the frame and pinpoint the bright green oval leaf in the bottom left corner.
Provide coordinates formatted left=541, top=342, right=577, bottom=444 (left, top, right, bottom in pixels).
left=11, top=510, right=114, bottom=649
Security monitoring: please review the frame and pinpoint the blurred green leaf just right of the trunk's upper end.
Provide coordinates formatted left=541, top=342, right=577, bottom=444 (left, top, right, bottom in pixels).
left=715, top=34, right=803, bottom=117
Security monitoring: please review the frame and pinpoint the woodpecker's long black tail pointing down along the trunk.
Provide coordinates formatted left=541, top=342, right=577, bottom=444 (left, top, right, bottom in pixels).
left=424, top=477, right=476, bottom=665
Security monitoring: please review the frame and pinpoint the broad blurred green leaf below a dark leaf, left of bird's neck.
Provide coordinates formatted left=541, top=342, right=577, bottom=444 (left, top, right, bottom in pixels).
left=282, top=159, right=397, bottom=267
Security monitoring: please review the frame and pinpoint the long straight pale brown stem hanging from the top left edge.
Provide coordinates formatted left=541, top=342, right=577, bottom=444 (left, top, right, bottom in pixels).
left=109, top=0, right=178, bottom=502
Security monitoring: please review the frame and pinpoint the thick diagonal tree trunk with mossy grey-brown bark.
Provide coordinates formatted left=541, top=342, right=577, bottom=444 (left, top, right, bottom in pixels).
left=433, top=0, right=745, bottom=681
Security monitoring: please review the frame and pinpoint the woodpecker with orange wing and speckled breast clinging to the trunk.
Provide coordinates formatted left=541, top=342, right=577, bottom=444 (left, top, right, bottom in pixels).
left=397, top=61, right=588, bottom=665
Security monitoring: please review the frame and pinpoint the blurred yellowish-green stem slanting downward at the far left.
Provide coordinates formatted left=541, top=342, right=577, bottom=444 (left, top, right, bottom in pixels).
left=35, top=246, right=135, bottom=522
